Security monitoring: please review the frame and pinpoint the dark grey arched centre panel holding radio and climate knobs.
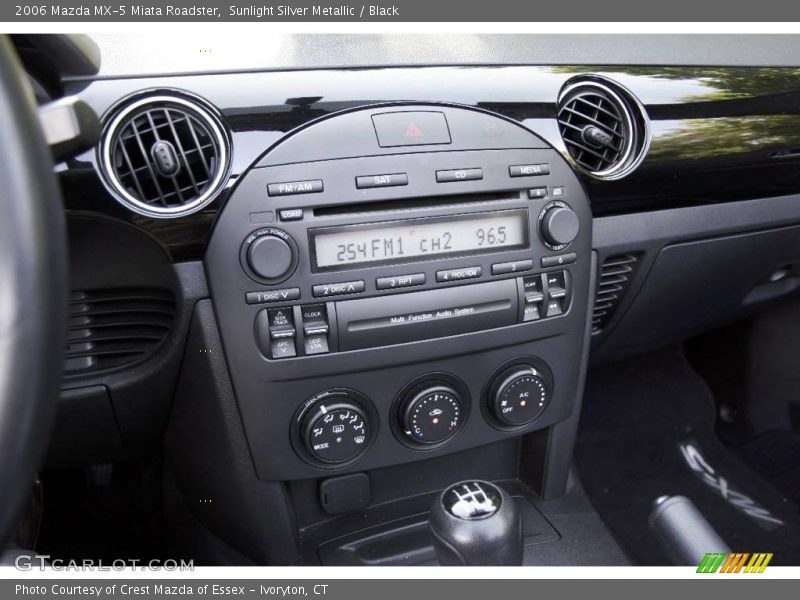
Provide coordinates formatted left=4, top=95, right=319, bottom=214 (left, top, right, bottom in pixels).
left=206, top=105, right=591, bottom=480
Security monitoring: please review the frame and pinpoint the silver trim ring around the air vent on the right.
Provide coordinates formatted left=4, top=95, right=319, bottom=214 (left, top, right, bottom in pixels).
left=556, top=75, right=650, bottom=181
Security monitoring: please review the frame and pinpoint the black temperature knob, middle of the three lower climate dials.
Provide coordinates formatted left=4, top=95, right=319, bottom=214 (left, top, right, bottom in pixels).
left=399, top=385, right=463, bottom=444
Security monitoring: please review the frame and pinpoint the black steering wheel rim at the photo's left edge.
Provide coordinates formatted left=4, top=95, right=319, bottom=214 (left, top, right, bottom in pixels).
left=0, top=36, right=68, bottom=549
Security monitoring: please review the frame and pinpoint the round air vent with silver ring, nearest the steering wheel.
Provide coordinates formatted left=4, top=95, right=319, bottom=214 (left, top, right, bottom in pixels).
left=99, top=92, right=230, bottom=219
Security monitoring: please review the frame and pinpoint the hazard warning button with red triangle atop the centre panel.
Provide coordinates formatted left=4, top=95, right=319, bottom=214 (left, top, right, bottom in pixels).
left=372, top=111, right=451, bottom=148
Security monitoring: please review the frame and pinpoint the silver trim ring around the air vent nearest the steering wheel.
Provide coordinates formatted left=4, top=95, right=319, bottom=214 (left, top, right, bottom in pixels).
left=98, top=93, right=230, bottom=219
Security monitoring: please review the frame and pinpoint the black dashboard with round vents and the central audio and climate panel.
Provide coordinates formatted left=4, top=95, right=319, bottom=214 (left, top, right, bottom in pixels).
left=31, top=36, right=800, bottom=562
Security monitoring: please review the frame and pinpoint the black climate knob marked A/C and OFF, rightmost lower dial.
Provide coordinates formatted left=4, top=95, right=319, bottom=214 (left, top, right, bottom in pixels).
left=489, top=365, right=550, bottom=427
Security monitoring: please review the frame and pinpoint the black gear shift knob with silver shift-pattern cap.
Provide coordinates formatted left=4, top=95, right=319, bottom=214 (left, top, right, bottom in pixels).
left=428, top=481, right=522, bottom=566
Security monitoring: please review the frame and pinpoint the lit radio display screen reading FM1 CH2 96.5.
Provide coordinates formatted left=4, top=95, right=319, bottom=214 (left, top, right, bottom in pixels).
left=309, top=209, right=528, bottom=270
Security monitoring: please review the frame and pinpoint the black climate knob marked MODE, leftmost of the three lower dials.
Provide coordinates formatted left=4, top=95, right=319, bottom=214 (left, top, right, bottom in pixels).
left=301, top=396, right=370, bottom=464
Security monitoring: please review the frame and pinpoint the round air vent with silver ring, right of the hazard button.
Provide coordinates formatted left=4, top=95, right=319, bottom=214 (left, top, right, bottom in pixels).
left=558, top=79, right=650, bottom=179
